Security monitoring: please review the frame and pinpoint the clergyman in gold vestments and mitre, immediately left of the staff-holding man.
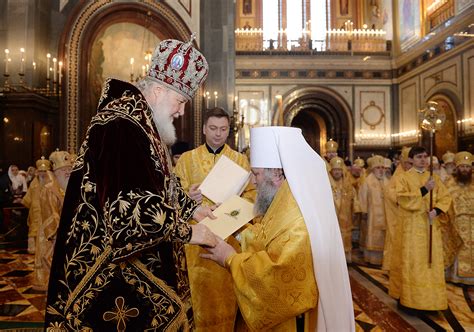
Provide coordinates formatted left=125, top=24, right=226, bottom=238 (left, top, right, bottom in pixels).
left=359, top=155, right=388, bottom=265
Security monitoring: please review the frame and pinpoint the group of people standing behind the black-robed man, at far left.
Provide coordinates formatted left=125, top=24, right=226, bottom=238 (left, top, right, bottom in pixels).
left=0, top=150, right=75, bottom=291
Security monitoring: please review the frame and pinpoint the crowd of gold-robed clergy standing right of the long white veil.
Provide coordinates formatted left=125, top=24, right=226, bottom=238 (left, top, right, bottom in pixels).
left=324, top=140, right=474, bottom=312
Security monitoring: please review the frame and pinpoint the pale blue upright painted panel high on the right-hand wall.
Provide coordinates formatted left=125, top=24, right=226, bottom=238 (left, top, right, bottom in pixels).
left=398, top=0, right=421, bottom=51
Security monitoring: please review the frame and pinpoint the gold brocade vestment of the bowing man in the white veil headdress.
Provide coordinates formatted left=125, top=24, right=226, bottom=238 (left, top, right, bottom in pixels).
left=229, top=182, right=318, bottom=332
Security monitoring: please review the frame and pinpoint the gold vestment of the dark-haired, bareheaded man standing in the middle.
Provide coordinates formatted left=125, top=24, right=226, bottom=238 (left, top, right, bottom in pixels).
left=174, top=144, right=256, bottom=332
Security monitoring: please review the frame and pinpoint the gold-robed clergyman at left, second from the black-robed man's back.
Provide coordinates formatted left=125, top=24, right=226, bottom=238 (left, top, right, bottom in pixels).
left=21, top=157, right=51, bottom=254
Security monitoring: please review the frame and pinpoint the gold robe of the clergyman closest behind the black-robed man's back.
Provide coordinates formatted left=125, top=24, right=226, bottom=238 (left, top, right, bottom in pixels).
left=33, top=175, right=64, bottom=290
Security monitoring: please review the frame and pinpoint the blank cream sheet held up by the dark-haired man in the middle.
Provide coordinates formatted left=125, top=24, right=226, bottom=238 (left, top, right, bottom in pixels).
left=199, top=156, right=250, bottom=203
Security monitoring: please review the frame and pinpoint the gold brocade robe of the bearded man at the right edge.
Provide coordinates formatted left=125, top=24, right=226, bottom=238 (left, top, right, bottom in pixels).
left=449, top=181, right=474, bottom=285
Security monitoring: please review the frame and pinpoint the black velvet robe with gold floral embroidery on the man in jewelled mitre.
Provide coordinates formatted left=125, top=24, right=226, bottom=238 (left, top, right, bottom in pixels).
left=45, top=79, right=196, bottom=331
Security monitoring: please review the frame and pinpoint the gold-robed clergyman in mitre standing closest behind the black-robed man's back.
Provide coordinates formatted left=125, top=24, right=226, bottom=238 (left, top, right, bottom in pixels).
left=33, top=151, right=72, bottom=291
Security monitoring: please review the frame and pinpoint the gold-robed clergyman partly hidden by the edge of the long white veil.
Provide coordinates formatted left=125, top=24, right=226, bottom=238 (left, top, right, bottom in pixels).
left=330, top=157, right=356, bottom=262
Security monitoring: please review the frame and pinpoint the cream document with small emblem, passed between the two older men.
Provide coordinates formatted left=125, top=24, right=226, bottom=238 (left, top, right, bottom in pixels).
left=200, top=195, right=254, bottom=239
